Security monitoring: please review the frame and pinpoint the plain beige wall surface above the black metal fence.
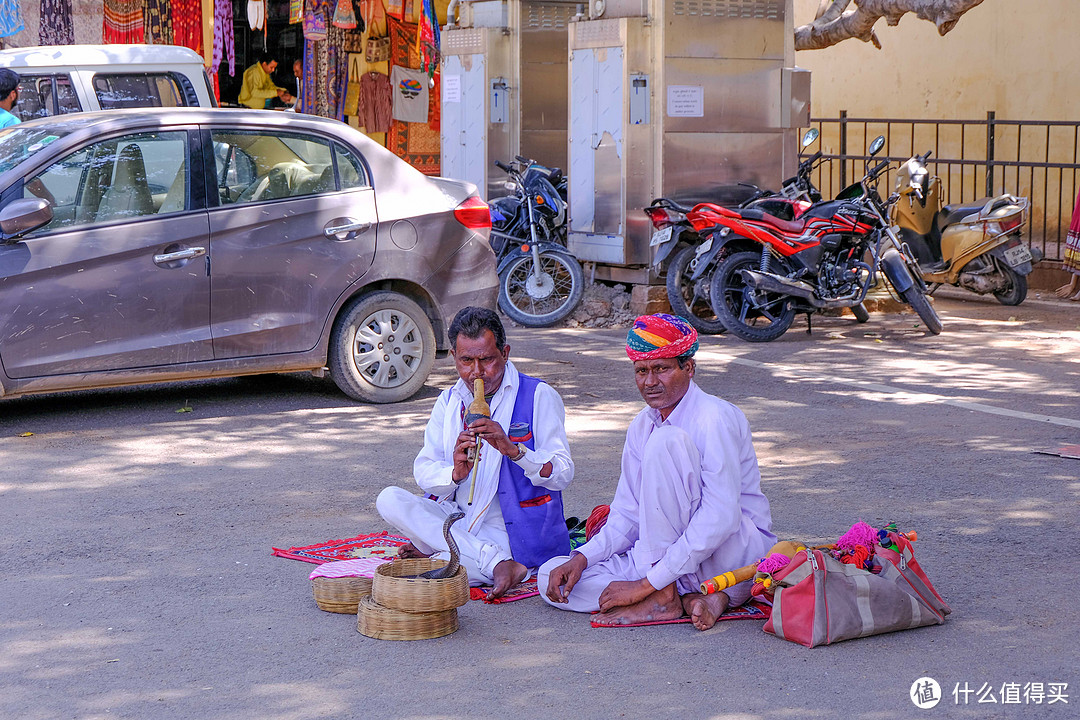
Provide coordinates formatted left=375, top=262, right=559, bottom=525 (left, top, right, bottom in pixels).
left=794, top=0, right=1080, bottom=120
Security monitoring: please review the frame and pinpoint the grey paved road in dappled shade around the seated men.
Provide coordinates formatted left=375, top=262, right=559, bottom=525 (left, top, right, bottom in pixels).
left=0, top=295, right=1080, bottom=720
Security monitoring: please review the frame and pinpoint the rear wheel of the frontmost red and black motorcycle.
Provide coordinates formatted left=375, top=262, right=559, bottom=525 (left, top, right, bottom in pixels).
left=710, top=252, right=795, bottom=342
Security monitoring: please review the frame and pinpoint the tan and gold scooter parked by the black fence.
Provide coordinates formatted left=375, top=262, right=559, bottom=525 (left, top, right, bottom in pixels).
left=891, top=150, right=1042, bottom=305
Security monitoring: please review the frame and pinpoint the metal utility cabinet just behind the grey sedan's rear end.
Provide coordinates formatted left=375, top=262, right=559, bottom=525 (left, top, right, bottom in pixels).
left=441, top=0, right=576, bottom=198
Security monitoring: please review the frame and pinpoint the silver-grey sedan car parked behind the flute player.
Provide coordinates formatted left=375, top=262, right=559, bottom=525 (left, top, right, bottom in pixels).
left=0, top=108, right=499, bottom=403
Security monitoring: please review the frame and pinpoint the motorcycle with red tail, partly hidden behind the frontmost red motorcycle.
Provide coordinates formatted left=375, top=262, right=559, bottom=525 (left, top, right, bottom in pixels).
left=645, top=128, right=825, bottom=335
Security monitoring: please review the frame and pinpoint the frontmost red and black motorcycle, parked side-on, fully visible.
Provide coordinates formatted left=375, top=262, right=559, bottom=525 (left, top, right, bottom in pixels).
left=710, top=136, right=942, bottom=342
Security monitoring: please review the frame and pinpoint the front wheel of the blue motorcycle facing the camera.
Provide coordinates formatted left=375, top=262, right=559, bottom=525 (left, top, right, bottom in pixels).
left=499, top=250, right=585, bottom=327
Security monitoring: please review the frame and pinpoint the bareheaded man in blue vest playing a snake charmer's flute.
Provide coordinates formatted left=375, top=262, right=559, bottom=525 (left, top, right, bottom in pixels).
left=376, top=308, right=573, bottom=599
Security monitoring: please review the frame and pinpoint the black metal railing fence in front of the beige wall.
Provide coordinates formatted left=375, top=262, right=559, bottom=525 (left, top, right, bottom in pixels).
left=808, top=111, right=1080, bottom=260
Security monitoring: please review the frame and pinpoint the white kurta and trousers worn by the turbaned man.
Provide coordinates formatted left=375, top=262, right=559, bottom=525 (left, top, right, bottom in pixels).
left=539, top=381, right=777, bottom=612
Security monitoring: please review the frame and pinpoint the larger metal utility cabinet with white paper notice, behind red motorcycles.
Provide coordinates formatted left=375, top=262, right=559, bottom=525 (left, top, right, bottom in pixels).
left=568, top=0, right=810, bottom=282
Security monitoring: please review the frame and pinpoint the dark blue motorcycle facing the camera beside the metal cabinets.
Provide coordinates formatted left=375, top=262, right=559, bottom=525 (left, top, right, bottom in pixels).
left=488, top=157, right=585, bottom=327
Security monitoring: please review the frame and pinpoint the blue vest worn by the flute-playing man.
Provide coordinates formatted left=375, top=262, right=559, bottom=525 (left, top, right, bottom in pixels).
left=498, top=372, right=570, bottom=568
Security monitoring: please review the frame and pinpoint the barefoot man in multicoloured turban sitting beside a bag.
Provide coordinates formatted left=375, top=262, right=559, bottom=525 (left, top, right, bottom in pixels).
left=539, top=314, right=777, bottom=630
